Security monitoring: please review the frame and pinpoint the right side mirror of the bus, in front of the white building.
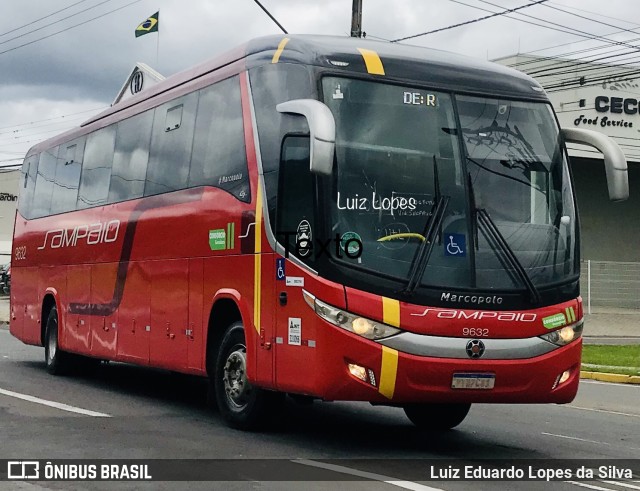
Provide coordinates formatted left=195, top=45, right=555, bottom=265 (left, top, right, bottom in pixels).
left=561, top=128, right=629, bottom=201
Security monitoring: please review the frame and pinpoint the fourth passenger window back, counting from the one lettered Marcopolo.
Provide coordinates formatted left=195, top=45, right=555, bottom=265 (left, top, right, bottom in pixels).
left=77, top=125, right=116, bottom=209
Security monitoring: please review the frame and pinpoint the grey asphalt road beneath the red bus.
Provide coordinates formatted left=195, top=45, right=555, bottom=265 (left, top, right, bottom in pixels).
left=0, top=329, right=640, bottom=491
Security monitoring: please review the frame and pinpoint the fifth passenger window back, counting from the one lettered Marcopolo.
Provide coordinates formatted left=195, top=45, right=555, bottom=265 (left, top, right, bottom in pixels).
left=51, top=138, right=84, bottom=214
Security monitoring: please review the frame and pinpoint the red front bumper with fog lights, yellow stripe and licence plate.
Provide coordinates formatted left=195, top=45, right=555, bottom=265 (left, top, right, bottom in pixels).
left=318, top=326, right=582, bottom=405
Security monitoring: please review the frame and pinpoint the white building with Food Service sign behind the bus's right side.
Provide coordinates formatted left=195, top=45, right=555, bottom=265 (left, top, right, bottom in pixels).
left=495, top=55, right=640, bottom=309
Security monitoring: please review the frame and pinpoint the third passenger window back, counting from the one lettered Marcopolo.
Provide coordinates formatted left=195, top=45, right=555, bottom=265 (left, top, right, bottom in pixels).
left=109, top=111, right=153, bottom=203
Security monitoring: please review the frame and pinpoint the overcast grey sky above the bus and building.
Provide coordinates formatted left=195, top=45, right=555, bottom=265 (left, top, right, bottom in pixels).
left=0, top=0, right=640, bottom=166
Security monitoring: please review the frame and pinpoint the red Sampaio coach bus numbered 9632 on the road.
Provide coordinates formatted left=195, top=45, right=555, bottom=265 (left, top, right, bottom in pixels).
left=10, top=36, right=628, bottom=428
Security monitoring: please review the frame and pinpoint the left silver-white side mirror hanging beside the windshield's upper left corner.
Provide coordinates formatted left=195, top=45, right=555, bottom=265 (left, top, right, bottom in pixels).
left=276, top=99, right=336, bottom=176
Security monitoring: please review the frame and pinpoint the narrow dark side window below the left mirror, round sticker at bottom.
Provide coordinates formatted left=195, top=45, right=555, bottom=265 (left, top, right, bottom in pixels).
left=276, top=136, right=316, bottom=262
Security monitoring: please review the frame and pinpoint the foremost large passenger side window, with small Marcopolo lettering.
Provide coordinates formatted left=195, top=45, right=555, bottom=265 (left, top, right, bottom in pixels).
left=189, top=76, right=251, bottom=202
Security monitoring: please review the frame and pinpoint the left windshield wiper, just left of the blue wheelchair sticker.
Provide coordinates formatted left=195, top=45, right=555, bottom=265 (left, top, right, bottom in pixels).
left=400, top=155, right=449, bottom=296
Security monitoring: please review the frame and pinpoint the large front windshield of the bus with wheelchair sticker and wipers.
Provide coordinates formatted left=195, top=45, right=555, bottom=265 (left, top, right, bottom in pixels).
left=323, top=77, right=578, bottom=293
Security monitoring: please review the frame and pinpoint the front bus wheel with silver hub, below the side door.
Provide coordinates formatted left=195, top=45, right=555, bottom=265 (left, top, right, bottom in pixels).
left=212, top=322, right=283, bottom=430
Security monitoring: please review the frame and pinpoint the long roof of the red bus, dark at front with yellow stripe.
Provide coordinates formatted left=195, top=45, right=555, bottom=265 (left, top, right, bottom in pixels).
left=27, top=35, right=548, bottom=156
